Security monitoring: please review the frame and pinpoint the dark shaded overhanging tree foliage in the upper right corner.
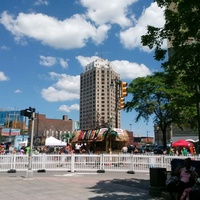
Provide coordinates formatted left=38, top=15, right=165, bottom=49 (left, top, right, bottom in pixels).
left=142, top=0, right=200, bottom=147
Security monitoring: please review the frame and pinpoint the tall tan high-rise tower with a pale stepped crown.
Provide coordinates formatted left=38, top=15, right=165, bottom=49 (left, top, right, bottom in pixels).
left=80, top=58, right=120, bottom=130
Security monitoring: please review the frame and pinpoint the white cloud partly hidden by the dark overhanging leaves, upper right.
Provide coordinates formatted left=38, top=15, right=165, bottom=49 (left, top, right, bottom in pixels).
left=119, top=3, right=167, bottom=52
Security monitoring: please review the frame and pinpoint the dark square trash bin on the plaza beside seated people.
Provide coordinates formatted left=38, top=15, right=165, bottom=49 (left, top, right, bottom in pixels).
left=150, top=167, right=167, bottom=187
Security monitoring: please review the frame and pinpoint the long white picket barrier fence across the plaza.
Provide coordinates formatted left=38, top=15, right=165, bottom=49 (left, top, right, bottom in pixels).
left=0, top=154, right=200, bottom=173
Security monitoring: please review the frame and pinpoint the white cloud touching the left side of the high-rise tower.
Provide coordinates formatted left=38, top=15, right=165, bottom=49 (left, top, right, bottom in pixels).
left=41, top=72, right=80, bottom=102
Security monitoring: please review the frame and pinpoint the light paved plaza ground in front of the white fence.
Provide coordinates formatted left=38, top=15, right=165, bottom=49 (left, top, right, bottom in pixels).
left=0, top=171, right=164, bottom=200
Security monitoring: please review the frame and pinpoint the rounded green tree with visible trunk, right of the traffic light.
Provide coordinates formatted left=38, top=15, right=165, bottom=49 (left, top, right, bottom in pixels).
left=125, top=72, right=194, bottom=147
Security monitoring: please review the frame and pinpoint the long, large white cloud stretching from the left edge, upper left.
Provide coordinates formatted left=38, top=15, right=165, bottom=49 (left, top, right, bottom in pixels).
left=0, top=11, right=110, bottom=49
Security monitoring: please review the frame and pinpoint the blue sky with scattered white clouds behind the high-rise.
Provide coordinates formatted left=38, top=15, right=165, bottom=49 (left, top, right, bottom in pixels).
left=0, top=0, right=165, bottom=136
